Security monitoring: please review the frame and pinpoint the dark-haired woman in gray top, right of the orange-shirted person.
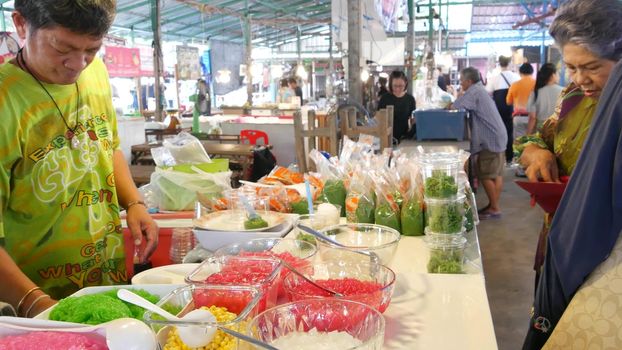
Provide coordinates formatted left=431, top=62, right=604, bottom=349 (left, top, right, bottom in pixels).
left=527, top=63, right=563, bottom=135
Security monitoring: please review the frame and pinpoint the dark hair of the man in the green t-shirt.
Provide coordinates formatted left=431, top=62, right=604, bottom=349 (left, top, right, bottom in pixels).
left=14, top=0, right=117, bottom=37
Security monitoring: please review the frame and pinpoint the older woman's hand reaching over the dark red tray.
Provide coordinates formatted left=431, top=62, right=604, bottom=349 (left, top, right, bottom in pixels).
left=519, top=145, right=560, bottom=182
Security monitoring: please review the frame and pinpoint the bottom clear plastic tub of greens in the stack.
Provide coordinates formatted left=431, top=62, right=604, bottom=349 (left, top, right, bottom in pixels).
left=424, top=235, right=467, bottom=274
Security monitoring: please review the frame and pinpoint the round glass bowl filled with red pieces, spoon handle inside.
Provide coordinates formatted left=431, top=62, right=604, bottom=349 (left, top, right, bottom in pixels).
left=283, top=261, right=395, bottom=312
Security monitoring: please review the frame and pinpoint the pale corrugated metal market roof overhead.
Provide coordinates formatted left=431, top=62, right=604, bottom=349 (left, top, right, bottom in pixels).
left=0, top=0, right=563, bottom=47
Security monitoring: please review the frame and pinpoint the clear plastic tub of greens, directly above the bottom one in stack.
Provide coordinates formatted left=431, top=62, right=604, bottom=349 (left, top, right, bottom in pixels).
left=425, top=194, right=465, bottom=233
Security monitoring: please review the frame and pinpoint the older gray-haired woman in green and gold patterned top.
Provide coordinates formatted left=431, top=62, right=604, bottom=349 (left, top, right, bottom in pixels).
left=517, top=0, right=622, bottom=286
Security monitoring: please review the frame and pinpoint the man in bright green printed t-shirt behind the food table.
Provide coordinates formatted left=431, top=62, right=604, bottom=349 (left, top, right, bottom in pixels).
left=0, top=0, right=158, bottom=317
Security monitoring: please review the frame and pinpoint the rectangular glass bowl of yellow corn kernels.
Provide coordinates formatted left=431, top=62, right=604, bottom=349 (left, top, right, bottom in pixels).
left=144, top=285, right=262, bottom=350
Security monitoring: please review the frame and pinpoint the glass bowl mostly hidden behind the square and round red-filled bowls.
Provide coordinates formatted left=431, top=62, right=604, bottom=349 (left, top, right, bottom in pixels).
left=214, top=238, right=317, bottom=296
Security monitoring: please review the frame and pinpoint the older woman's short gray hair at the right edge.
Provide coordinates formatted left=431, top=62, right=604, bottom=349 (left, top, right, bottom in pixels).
left=549, top=0, right=622, bottom=61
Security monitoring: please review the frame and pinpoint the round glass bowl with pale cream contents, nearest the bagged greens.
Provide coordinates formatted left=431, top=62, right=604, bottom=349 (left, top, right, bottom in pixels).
left=317, top=223, right=400, bottom=266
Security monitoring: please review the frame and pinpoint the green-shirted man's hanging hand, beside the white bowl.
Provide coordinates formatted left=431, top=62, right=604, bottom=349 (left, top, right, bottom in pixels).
left=126, top=204, right=159, bottom=263
